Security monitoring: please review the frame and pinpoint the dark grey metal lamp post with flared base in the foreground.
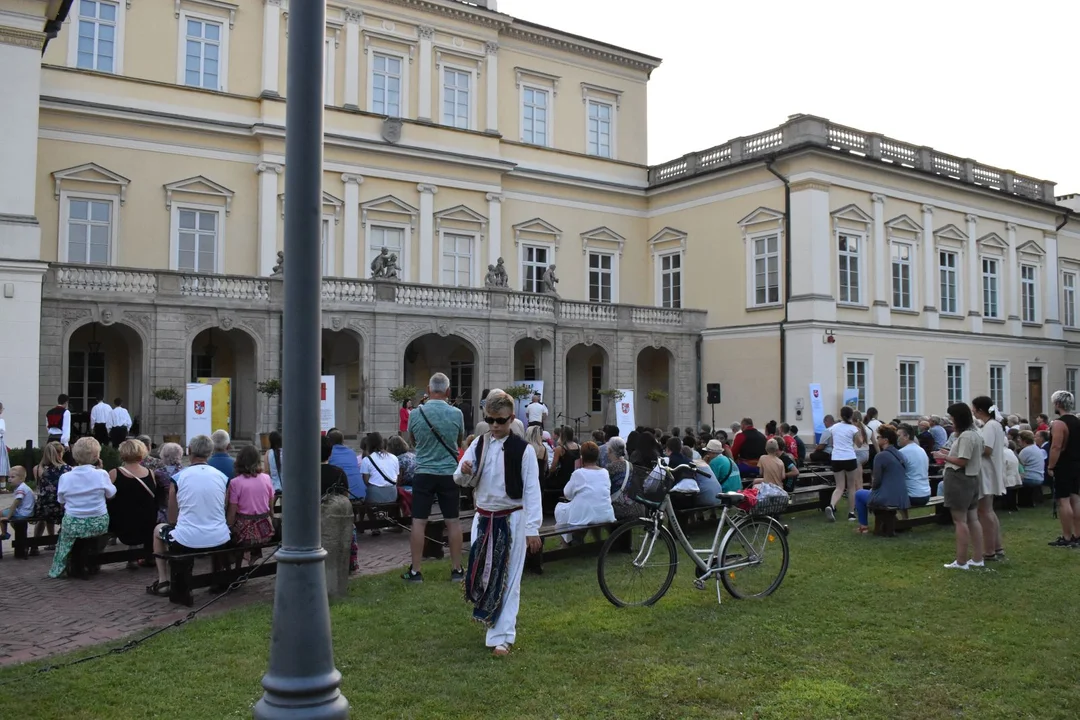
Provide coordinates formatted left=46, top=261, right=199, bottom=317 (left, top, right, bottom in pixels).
left=255, top=0, right=349, bottom=720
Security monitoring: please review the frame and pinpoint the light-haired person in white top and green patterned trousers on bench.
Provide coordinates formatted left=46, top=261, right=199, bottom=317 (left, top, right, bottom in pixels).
left=49, top=433, right=117, bottom=578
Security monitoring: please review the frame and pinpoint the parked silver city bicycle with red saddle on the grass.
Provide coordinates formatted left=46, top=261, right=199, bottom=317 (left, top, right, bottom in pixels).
left=596, top=461, right=789, bottom=608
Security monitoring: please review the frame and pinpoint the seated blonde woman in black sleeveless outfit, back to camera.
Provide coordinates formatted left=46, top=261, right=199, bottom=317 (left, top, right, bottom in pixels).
left=108, top=440, right=159, bottom=570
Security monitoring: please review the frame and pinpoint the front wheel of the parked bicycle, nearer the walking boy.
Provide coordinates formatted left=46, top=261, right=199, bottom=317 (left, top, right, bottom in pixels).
left=596, top=520, right=678, bottom=608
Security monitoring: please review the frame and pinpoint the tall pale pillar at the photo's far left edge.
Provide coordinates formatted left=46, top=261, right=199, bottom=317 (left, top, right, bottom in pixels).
left=0, top=15, right=48, bottom=447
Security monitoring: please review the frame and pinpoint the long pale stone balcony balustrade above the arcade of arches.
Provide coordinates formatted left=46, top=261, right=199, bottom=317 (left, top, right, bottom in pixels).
left=42, top=263, right=705, bottom=332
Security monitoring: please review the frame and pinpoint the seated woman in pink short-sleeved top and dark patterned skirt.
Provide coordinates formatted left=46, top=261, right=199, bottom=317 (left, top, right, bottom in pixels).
left=225, top=445, right=274, bottom=567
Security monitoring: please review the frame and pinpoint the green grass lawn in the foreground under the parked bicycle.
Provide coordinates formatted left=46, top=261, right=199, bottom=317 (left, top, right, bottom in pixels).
left=0, top=506, right=1080, bottom=720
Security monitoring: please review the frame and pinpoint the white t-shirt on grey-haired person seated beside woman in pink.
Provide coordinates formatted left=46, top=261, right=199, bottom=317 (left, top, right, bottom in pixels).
left=170, top=463, right=229, bottom=549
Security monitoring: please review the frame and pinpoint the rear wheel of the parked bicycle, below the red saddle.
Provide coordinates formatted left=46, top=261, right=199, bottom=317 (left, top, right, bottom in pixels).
left=720, top=518, right=789, bottom=600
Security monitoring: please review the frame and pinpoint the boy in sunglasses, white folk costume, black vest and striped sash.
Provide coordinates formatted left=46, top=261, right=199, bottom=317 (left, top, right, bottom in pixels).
left=456, top=390, right=543, bottom=657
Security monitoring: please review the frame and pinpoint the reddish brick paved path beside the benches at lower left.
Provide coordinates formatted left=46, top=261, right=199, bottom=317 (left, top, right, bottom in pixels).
left=0, top=531, right=408, bottom=666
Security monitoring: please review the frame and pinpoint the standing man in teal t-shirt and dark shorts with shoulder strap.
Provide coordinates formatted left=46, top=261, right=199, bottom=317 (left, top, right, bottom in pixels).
left=402, top=372, right=460, bottom=583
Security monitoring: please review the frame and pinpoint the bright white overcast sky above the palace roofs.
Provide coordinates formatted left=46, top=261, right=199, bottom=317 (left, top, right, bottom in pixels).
left=499, top=0, right=1080, bottom=195
